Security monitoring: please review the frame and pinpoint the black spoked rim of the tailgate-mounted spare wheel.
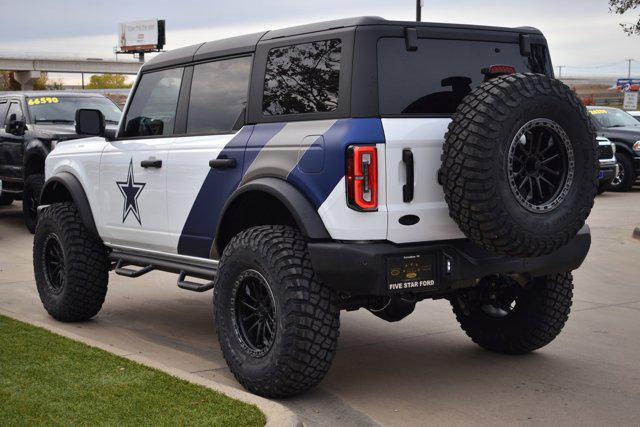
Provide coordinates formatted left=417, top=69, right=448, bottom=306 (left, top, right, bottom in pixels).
left=507, top=118, right=575, bottom=213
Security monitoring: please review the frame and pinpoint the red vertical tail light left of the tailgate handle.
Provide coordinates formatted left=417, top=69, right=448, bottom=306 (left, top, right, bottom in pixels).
left=346, top=145, right=378, bottom=211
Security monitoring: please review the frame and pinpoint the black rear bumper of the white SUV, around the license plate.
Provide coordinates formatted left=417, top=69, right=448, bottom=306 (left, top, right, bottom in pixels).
left=308, top=225, right=591, bottom=296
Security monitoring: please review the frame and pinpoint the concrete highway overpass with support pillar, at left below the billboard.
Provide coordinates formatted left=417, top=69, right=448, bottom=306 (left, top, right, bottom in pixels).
left=0, top=55, right=142, bottom=90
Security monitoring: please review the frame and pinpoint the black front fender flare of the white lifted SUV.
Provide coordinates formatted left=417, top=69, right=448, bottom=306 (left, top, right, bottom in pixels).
left=40, top=172, right=102, bottom=241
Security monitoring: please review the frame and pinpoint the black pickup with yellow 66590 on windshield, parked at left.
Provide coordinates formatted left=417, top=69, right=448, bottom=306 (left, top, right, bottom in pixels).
left=0, top=91, right=121, bottom=233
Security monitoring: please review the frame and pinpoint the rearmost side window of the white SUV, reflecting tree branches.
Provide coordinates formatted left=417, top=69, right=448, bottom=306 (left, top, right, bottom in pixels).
left=262, top=39, right=342, bottom=116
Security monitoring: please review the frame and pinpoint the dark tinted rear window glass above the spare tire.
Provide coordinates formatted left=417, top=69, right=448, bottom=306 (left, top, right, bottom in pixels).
left=378, top=38, right=549, bottom=115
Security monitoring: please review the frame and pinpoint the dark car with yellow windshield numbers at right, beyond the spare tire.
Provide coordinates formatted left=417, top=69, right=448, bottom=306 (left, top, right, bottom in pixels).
left=588, top=106, right=640, bottom=191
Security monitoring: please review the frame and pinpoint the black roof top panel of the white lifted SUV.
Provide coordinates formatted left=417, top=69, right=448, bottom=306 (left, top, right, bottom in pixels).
left=142, top=16, right=542, bottom=71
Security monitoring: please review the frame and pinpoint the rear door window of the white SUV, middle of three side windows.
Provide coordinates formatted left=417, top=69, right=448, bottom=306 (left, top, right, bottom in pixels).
left=187, top=57, right=251, bottom=134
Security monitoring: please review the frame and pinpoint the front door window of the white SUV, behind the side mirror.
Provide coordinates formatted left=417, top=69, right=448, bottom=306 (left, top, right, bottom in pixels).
left=124, top=68, right=183, bottom=137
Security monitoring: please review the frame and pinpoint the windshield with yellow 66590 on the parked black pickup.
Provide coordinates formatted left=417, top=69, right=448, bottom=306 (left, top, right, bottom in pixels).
left=27, top=96, right=121, bottom=124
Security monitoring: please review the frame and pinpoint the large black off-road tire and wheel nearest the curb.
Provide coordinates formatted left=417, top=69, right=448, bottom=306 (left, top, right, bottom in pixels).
left=213, top=225, right=340, bottom=397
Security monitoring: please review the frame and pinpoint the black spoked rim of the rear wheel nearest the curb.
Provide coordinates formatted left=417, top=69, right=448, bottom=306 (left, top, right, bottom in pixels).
left=233, top=270, right=276, bottom=357
